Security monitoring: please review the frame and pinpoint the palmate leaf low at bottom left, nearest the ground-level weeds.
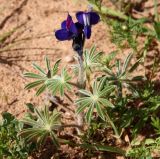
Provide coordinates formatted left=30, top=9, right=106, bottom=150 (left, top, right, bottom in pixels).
left=20, top=106, right=61, bottom=147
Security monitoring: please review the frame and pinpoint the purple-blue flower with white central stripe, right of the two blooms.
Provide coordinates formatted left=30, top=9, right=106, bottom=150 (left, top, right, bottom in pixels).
left=76, top=11, right=100, bottom=39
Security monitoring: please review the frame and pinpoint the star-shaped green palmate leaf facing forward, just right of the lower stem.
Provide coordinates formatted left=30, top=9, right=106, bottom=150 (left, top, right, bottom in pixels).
left=76, top=78, right=115, bottom=123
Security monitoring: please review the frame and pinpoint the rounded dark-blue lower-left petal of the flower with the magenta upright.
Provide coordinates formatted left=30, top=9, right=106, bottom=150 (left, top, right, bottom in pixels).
left=55, top=29, right=72, bottom=41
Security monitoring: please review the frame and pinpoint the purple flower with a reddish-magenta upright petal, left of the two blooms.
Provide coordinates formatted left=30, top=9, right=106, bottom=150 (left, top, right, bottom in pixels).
left=55, top=14, right=79, bottom=41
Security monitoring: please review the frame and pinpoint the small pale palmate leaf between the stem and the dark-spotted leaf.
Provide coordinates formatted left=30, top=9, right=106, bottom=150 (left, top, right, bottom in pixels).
left=46, top=68, right=71, bottom=96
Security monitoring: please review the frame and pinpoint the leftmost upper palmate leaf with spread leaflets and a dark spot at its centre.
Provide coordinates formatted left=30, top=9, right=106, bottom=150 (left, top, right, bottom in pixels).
left=24, top=57, right=63, bottom=96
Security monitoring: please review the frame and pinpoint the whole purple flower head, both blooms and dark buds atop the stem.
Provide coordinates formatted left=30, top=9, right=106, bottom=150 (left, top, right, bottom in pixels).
left=55, top=11, right=100, bottom=56
